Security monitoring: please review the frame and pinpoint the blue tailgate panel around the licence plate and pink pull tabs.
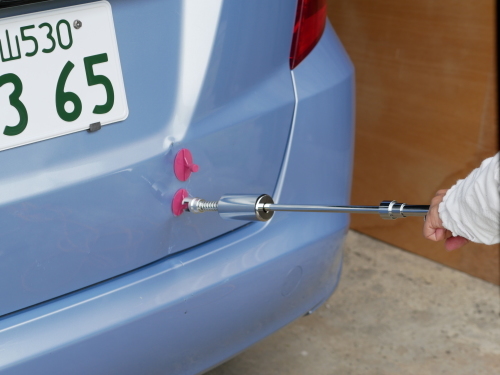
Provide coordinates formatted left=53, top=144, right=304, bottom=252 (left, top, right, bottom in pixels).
left=0, top=0, right=295, bottom=316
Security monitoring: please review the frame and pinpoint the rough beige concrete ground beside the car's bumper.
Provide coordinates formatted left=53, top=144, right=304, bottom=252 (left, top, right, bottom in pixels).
left=207, top=232, right=500, bottom=375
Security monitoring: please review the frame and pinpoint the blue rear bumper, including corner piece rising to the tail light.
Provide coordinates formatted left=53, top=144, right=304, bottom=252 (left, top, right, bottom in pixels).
left=0, top=22, right=354, bottom=375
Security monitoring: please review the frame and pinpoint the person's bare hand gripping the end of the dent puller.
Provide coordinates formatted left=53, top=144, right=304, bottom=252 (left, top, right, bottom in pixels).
left=424, top=189, right=469, bottom=251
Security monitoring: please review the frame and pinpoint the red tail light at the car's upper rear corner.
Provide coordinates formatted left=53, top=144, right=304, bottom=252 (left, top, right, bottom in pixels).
left=290, top=0, right=326, bottom=69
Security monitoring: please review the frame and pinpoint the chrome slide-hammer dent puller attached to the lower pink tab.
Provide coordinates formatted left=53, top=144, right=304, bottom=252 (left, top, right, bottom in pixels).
left=183, top=194, right=429, bottom=221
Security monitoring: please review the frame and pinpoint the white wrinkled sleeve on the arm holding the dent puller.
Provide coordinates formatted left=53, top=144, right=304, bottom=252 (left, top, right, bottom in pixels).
left=439, top=152, right=500, bottom=245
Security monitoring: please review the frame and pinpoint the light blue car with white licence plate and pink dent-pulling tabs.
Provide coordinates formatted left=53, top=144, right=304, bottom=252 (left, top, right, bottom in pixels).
left=0, top=0, right=354, bottom=375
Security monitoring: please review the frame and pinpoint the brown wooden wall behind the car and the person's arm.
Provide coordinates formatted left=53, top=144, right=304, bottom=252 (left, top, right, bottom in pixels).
left=328, top=0, right=500, bottom=284
